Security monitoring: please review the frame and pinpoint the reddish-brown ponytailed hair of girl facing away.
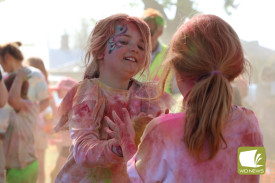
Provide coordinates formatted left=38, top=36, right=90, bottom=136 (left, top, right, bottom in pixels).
left=160, top=15, right=246, bottom=160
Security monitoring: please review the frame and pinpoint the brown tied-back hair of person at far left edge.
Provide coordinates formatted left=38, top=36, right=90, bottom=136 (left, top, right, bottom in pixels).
left=0, top=42, right=24, bottom=62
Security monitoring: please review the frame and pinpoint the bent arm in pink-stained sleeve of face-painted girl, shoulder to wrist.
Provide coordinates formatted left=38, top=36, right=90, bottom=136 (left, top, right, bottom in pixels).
left=62, top=81, right=123, bottom=167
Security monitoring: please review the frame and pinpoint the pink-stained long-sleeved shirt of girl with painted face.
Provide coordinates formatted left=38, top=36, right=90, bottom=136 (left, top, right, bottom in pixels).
left=55, top=78, right=174, bottom=183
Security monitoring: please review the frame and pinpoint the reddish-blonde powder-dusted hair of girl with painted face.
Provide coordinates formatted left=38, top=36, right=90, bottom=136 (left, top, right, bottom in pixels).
left=84, top=14, right=151, bottom=79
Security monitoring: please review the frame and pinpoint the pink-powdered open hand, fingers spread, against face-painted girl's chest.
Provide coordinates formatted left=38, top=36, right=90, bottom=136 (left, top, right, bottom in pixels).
left=105, top=108, right=135, bottom=144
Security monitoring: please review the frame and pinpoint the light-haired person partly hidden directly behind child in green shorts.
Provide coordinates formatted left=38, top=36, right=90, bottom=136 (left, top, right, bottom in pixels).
left=23, top=57, right=52, bottom=183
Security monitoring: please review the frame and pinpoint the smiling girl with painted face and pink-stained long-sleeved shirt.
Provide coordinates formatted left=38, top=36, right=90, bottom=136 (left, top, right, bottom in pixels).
left=55, top=14, right=172, bottom=183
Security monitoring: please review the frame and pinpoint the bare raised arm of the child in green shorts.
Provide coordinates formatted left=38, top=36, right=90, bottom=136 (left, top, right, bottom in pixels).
left=8, top=68, right=29, bottom=111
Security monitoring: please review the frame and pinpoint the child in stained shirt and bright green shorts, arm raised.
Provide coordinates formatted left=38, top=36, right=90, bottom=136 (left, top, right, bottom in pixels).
left=4, top=68, right=39, bottom=183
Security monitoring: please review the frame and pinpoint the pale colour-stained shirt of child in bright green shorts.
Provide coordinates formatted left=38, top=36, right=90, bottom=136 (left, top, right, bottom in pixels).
left=4, top=100, right=39, bottom=169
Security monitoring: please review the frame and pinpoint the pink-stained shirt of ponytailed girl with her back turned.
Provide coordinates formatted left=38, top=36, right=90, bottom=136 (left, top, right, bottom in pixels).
left=127, top=106, right=263, bottom=183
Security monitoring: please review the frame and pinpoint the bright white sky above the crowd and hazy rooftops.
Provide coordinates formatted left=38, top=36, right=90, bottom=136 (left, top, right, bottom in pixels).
left=0, top=0, right=275, bottom=68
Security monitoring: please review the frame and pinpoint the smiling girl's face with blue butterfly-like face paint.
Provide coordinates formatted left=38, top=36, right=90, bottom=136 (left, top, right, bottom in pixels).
left=100, top=23, right=145, bottom=79
